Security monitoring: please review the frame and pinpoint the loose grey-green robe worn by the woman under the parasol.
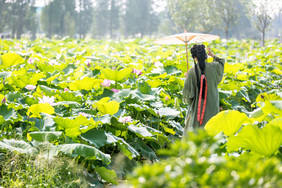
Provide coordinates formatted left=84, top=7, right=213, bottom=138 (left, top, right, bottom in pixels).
left=183, top=57, right=225, bottom=137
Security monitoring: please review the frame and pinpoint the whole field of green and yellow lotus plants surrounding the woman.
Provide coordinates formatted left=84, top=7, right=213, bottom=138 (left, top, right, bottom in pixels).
left=0, top=38, right=282, bottom=187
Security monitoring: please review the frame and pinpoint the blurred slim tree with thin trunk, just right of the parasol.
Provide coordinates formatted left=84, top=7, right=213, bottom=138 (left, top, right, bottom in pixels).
left=215, top=0, right=239, bottom=39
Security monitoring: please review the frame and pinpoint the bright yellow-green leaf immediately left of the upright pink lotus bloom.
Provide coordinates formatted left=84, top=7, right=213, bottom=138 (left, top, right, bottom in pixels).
left=69, top=77, right=102, bottom=91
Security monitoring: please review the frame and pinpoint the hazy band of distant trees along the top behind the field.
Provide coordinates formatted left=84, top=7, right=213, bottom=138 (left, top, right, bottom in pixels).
left=0, top=0, right=282, bottom=42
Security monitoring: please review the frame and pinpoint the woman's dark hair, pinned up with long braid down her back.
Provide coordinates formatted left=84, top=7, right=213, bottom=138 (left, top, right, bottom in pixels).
left=191, top=44, right=208, bottom=98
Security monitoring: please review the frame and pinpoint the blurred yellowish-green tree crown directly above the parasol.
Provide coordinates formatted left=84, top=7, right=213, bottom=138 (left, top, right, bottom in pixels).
left=168, top=0, right=218, bottom=33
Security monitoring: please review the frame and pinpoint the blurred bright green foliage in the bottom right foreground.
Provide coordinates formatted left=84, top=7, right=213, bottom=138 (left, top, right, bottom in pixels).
left=128, top=130, right=282, bottom=187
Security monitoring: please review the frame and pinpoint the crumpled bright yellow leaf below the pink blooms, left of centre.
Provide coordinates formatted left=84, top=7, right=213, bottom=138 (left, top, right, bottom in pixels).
left=93, top=97, right=119, bottom=115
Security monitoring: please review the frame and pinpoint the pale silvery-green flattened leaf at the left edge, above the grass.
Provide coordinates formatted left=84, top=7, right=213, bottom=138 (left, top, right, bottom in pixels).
left=0, top=139, right=37, bottom=154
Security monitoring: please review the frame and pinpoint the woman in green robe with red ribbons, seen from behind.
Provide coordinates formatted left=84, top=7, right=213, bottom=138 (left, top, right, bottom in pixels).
left=183, top=45, right=224, bottom=138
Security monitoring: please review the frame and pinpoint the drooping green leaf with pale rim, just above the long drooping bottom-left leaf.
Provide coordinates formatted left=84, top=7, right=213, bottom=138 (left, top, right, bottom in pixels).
left=29, top=131, right=62, bottom=142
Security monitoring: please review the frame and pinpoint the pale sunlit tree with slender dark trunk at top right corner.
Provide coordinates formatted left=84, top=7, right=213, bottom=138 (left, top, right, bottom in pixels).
left=243, top=0, right=282, bottom=46
